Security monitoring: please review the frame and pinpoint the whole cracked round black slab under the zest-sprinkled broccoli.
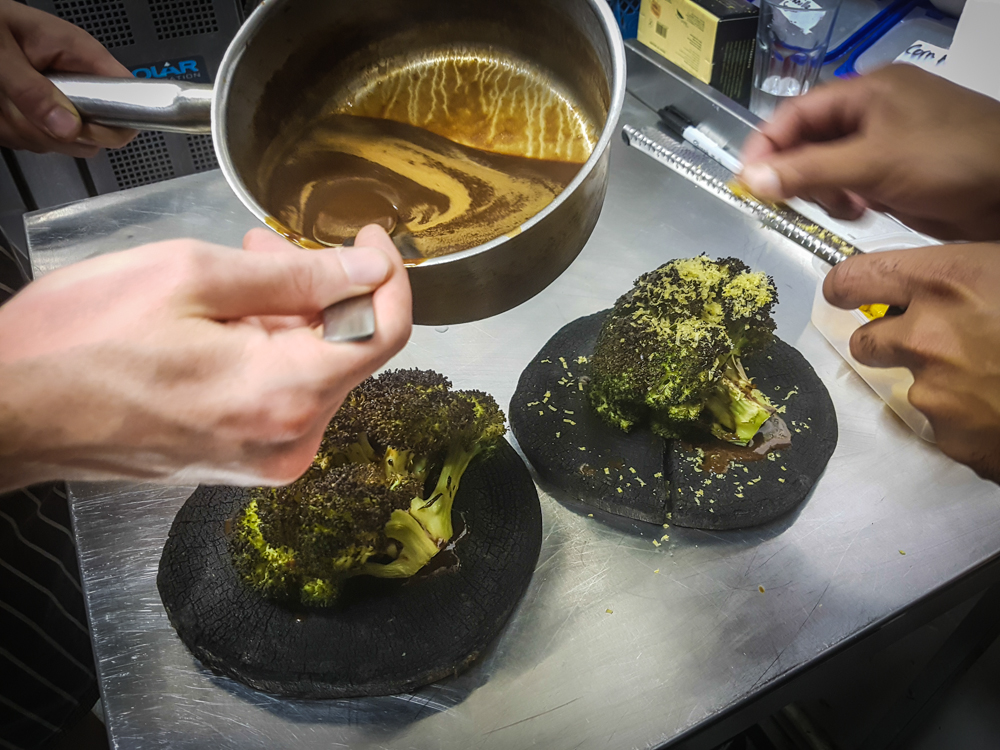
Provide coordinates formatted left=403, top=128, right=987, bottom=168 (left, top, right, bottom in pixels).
left=509, top=311, right=837, bottom=529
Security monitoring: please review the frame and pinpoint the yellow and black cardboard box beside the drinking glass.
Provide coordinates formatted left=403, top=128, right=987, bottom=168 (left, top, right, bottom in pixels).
left=638, top=0, right=758, bottom=105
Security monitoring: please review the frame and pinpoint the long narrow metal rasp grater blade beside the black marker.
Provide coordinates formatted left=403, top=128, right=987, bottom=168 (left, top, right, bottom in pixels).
left=622, top=125, right=861, bottom=265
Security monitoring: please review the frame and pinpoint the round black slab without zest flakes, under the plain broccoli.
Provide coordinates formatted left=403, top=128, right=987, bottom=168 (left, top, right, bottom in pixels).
left=157, top=441, right=542, bottom=698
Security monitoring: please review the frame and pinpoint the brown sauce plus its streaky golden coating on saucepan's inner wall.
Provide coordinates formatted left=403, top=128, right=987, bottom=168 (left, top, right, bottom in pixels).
left=255, top=52, right=600, bottom=264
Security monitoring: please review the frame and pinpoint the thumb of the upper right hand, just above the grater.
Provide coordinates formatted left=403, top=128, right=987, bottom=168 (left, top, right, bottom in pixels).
left=740, top=138, right=884, bottom=200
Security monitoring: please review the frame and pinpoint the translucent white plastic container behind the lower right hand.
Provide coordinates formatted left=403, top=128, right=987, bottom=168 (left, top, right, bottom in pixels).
left=812, top=234, right=934, bottom=443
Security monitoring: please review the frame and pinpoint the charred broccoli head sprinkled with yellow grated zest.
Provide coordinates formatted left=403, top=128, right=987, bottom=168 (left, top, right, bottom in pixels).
left=589, top=256, right=778, bottom=444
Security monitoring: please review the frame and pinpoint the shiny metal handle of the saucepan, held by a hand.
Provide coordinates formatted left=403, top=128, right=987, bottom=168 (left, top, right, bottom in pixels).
left=48, top=73, right=212, bottom=133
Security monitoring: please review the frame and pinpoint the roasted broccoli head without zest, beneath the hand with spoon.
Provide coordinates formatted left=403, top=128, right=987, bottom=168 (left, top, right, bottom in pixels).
left=231, top=370, right=506, bottom=605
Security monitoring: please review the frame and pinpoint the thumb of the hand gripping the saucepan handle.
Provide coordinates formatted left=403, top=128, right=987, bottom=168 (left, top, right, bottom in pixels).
left=0, top=27, right=83, bottom=142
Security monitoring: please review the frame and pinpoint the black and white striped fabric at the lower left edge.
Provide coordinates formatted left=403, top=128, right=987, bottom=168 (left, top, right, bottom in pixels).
left=0, top=234, right=97, bottom=750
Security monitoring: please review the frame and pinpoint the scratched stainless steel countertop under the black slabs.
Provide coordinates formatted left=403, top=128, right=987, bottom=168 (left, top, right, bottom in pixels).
left=28, top=91, right=1000, bottom=750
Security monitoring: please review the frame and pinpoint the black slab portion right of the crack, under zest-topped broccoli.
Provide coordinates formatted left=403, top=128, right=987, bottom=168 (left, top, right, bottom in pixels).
left=667, top=338, right=837, bottom=529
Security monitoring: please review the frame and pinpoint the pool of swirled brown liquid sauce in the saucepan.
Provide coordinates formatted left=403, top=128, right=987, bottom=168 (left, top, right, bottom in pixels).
left=262, top=114, right=581, bottom=257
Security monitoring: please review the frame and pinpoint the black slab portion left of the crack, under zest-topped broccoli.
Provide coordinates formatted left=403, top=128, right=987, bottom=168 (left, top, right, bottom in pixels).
left=509, top=311, right=670, bottom=524
